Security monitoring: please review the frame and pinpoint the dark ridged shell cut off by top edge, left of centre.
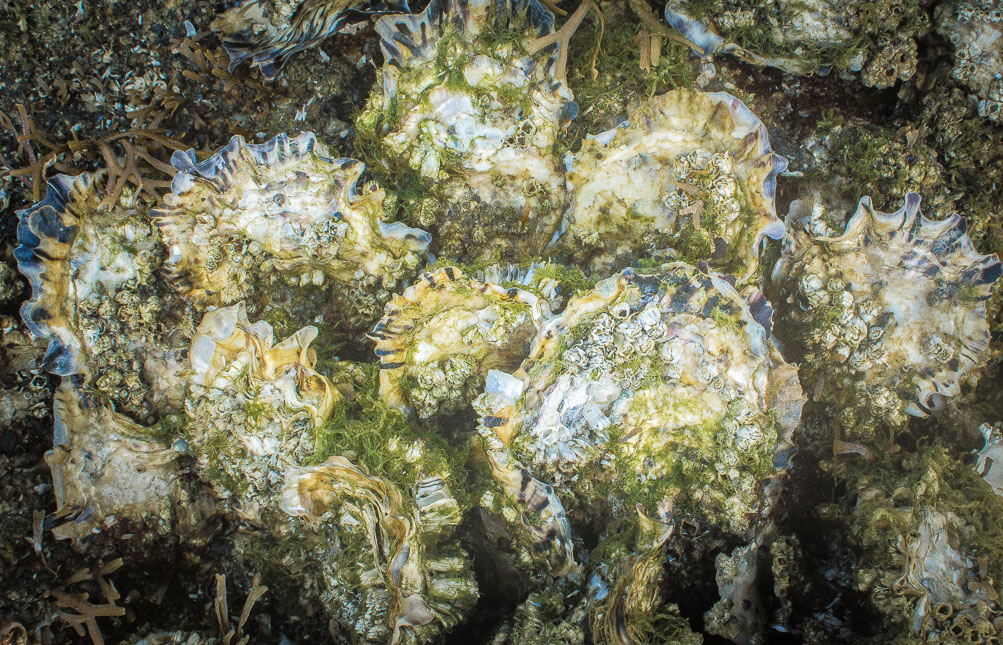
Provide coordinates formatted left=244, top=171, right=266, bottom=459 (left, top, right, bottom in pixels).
left=211, top=0, right=399, bottom=78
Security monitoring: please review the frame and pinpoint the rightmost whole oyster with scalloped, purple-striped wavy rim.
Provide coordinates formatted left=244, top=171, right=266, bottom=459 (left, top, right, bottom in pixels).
left=773, top=193, right=1003, bottom=437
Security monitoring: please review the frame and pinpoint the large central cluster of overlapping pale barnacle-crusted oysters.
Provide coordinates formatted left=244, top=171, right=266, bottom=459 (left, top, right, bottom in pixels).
left=16, top=0, right=1001, bottom=644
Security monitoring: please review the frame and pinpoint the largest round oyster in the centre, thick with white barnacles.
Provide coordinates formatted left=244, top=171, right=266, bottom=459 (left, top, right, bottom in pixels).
left=475, top=263, right=803, bottom=549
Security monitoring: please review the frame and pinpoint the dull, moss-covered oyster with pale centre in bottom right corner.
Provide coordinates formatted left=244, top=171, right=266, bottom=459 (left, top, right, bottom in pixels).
left=825, top=445, right=1003, bottom=643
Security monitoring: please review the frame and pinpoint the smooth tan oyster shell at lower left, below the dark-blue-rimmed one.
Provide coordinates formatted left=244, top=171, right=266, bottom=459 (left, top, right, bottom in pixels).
left=45, top=377, right=179, bottom=541
